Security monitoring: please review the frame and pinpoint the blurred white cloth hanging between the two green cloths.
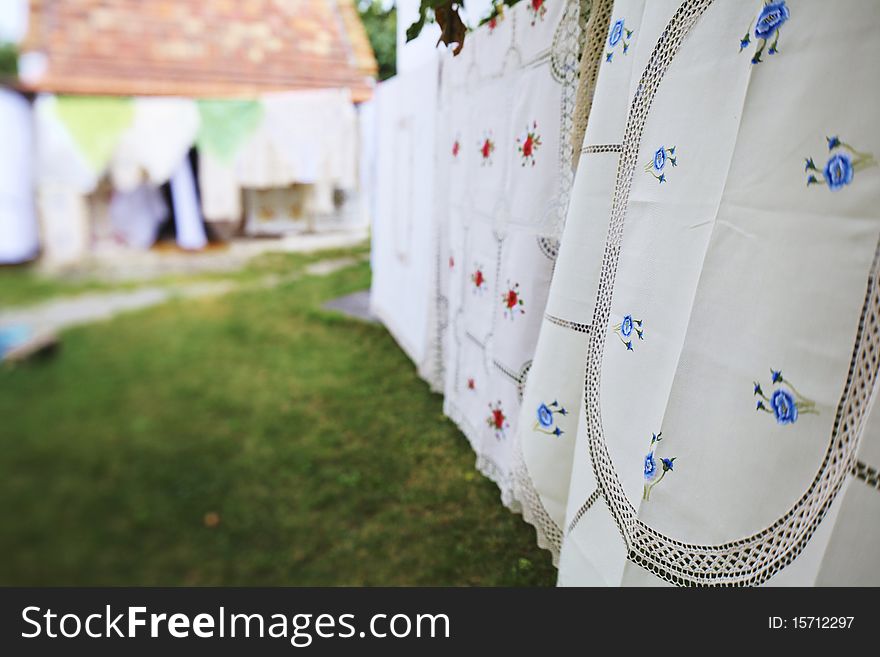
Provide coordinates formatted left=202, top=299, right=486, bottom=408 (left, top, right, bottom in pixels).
left=110, top=98, right=199, bottom=191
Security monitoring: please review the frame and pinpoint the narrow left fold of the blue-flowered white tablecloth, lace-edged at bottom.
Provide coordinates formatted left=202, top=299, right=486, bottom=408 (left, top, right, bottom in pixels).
left=514, top=0, right=648, bottom=562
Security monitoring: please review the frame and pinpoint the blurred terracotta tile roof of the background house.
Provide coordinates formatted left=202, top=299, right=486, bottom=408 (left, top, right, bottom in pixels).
left=23, top=0, right=376, bottom=100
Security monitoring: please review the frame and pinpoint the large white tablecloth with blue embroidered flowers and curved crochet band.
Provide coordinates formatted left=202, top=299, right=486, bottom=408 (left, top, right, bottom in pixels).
left=517, top=0, right=880, bottom=585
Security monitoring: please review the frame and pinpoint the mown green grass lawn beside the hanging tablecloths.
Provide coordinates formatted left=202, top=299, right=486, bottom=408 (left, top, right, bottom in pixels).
left=0, top=253, right=555, bottom=585
